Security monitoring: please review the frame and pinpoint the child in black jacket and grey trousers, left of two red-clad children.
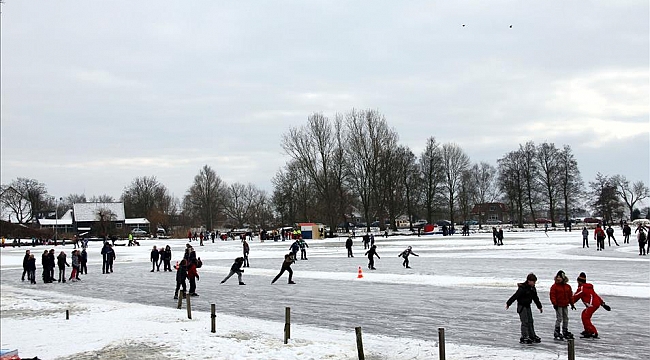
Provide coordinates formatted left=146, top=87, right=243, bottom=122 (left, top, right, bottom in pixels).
left=506, top=273, right=542, bottom=344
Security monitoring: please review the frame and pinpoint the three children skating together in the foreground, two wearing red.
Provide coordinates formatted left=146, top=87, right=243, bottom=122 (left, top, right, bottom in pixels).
left=506, top=270, right=611, bottom=344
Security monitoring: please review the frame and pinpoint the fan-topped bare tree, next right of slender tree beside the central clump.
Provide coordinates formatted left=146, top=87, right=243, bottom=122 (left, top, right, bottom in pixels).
left=441, top=143, right=470, bottom=224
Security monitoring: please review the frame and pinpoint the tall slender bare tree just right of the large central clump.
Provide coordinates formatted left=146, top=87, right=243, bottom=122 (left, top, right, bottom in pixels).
left=420, top=137, right=444, bottom=223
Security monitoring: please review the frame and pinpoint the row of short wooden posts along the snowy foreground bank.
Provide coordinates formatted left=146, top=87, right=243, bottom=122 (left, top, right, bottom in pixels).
left=65, top=302, right=576, bottom=360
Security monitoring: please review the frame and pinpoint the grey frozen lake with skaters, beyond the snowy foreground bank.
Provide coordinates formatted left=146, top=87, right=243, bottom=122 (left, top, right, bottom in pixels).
left=1, top=230, right=650, bottom=359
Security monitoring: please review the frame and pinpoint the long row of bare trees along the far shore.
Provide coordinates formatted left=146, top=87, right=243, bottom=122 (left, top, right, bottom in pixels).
left=0, top=110, right=650, bottom=233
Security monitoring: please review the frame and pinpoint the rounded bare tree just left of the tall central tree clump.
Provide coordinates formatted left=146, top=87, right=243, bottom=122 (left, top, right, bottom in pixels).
left=184, top=165, right=225, bottom=230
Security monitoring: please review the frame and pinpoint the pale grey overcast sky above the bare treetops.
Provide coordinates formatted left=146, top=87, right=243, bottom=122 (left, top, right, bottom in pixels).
left=1, top=0, right=650, bottom=198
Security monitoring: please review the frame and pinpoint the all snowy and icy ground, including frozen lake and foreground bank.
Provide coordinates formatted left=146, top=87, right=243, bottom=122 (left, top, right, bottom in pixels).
left=0, top=229, right=650, bottom=360
